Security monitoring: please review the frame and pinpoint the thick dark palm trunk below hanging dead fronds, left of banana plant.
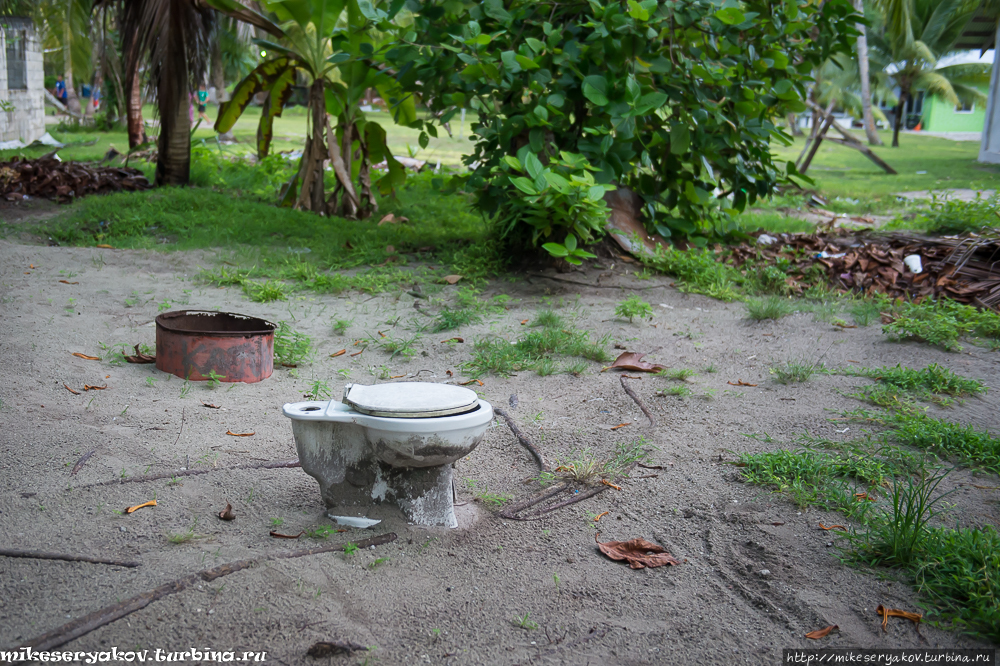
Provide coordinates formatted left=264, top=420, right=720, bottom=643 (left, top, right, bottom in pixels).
left=154, top=71, right=191, bottom=186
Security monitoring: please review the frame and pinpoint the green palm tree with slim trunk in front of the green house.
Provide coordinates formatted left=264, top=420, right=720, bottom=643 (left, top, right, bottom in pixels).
left=869, top=0, right=990, bottom=148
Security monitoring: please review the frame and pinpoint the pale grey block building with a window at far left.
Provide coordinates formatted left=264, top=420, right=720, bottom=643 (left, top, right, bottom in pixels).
left=0, top=17, right=45, bottom=144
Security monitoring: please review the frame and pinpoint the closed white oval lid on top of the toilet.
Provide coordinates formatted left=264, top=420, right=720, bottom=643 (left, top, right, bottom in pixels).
left=343, top=382, right=479, bottom=418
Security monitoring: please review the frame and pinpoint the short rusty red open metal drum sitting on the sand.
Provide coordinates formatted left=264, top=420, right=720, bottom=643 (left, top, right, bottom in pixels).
left=156, top=310, right=277, bottom=384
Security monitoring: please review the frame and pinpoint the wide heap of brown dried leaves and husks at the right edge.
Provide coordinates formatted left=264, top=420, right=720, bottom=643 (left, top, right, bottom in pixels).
left=731, top=229, right=1000, bottom=309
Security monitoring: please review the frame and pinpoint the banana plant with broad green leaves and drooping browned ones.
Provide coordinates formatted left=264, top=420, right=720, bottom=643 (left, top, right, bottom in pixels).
left=207, top=0, right=418, bottom=219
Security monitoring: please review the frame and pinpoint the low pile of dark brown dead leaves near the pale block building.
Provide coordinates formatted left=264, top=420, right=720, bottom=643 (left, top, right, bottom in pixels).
left=0, top=152, right=151, bottom=203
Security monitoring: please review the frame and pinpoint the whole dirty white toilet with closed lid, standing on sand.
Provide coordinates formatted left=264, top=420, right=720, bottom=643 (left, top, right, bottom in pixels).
left=282, top=382, right=493, bottom=527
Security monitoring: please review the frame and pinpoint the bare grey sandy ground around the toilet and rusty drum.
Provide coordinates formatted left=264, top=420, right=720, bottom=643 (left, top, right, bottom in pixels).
left=0, top=222, right=1000, bottom=665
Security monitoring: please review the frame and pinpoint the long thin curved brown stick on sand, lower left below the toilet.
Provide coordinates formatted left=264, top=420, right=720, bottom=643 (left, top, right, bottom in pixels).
left=17, top=532, right=396, bottom=650
